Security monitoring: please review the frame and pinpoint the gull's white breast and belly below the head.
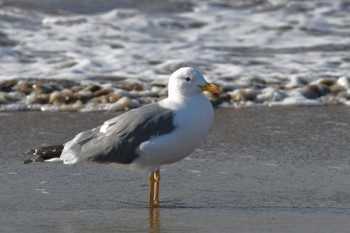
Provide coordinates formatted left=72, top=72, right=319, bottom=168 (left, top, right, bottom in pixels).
left=133, top=95, right=213, bottom=168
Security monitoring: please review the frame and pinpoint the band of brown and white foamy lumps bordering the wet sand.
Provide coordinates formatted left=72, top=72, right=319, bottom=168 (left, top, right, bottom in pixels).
left=0, top=77, right=350, bottom=112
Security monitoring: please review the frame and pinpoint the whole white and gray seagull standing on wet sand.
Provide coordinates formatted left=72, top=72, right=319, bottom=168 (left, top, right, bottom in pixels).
left=24, top=67, right=220, bottom=207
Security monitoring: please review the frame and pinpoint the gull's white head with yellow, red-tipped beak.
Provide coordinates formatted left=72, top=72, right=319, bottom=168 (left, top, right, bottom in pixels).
left=168, top=67, right=220, bottom=97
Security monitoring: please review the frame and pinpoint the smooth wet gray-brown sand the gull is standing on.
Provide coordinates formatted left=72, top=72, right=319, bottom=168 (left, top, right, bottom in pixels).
left=0, top=106, right=350, bottom=233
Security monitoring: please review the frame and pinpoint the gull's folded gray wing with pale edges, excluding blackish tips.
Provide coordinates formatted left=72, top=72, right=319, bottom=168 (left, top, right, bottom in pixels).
left=61, top=103, right=175, bottom=164
